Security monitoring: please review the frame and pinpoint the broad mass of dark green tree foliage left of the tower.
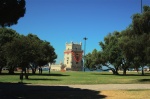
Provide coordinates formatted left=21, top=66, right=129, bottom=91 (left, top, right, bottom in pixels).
left=0, top=28, right=57, bottom=73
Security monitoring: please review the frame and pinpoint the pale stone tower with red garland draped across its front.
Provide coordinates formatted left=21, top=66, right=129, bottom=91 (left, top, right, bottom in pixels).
left=64, top=42, right=83, bottom=71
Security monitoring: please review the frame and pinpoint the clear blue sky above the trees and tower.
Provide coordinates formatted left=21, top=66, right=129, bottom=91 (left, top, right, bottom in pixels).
left=11, top=0, right=150, bottom=64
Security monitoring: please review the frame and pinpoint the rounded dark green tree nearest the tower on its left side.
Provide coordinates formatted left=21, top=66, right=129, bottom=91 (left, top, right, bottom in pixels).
left=27, top=34, right=57, bottom=74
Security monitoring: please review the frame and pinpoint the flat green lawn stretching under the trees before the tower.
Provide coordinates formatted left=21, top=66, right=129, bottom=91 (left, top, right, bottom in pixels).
left=0, top=71, right=150, bottom=85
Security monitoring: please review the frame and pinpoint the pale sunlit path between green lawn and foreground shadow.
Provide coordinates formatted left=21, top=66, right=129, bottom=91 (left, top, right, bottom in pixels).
left=30, top=84, right=150, bottom=91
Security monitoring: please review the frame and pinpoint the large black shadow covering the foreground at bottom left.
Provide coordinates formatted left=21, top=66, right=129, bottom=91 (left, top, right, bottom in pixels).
left=0, top=83, right=107, bottom=99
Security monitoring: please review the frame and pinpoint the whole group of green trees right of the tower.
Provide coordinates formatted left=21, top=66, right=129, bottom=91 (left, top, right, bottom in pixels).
left=86, top=6, right=150, bottom=75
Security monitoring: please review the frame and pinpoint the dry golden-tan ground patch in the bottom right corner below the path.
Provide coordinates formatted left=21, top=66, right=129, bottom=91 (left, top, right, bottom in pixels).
left=100, top=90, right=150, bottom=99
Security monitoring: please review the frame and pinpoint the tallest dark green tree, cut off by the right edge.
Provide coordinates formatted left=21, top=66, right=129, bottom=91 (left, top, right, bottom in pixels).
left=131, top=6, right=150, bottom=75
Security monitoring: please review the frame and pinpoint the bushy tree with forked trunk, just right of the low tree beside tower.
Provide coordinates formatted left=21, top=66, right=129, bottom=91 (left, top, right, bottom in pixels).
left=100, top=31, right=122, bottom=75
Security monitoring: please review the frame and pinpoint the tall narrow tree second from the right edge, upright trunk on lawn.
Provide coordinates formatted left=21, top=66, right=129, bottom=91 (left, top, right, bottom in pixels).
left=118, top=25, right=138, bottom=75
